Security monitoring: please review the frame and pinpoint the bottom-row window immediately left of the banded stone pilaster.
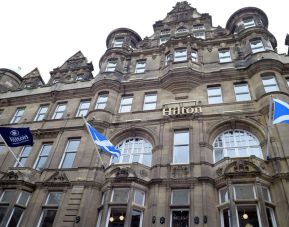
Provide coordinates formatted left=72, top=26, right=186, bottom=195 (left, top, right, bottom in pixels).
left=37, top=192, right=62, bottom=227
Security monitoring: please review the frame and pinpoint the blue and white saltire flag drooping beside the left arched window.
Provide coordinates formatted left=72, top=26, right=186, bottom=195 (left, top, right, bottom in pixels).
left=86, top=123, right=120, bottom=157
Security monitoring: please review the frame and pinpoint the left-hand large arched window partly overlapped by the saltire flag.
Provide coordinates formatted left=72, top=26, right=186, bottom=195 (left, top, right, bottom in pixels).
left=111, top=137, right=152, bottom=166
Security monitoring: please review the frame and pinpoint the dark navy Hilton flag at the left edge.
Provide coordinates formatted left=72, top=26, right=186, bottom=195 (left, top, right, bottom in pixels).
left=0, top=127, right=33, bottom=147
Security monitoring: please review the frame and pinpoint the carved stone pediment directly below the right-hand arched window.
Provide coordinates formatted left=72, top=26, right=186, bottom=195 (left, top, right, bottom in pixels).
left=217, top=159, right=261, bottom=176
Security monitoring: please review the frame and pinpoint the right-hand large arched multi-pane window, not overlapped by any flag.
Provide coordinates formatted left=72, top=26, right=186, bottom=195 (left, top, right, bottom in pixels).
left=213, top=129, right=263, bottom=162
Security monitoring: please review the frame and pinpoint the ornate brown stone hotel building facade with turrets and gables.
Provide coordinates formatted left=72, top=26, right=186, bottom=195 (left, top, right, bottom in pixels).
left=0, top=2, right=289, bottom=227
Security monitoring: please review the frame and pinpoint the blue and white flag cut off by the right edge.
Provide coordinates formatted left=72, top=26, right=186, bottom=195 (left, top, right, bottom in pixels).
left=273, top=99, right=289, bottom=124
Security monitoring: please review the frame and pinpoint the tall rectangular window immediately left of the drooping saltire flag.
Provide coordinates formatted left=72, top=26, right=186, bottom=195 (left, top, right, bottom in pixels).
left=59, top=139, right=80, bottom=168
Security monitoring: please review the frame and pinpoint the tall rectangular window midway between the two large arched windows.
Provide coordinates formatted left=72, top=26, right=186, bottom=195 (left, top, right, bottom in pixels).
left=173, top=130, right=190, bottom=164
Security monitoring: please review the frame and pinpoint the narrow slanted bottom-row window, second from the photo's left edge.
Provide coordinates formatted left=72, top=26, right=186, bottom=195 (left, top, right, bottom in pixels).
left=6, top=191, right=30, bottom=227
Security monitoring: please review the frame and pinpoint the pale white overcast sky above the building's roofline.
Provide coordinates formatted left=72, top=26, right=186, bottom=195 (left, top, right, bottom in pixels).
left=0, top=0, right=289, bottom=82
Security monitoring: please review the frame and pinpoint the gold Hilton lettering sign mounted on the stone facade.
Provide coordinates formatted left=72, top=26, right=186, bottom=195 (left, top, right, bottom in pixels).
left=163, top=100, right=202, bottom=116
